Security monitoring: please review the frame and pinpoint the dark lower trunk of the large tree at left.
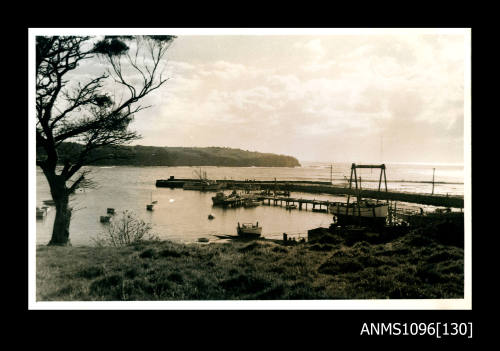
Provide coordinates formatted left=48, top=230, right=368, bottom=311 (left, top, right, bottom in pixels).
left=49, top=175, right=71, bottom=246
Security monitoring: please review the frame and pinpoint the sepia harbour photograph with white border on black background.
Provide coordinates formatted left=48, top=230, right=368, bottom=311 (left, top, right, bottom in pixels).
left=28, top=28, right=472, bottom=309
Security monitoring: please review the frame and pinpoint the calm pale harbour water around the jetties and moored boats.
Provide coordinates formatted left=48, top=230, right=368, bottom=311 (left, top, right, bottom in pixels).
left=36, top=163, right=464, bottom=245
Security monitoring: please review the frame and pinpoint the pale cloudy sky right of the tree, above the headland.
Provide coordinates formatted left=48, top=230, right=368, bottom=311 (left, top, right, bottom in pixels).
left=74, top=31, right=469, bottom=163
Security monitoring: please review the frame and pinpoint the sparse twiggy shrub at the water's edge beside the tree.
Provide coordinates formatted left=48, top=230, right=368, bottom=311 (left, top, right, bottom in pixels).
left=92, top=211, right=159, bottom=247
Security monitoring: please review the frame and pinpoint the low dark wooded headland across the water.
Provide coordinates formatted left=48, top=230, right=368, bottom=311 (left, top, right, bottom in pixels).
left=37, top=143, right=301, bottom=167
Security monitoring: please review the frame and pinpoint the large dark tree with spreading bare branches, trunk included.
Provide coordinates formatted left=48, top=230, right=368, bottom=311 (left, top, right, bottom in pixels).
left=36, top=36, right=175, bottom=245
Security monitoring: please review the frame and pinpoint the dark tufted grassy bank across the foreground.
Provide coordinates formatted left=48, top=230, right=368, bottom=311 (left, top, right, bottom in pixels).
left=36, top=220, right=464, bottom=301
